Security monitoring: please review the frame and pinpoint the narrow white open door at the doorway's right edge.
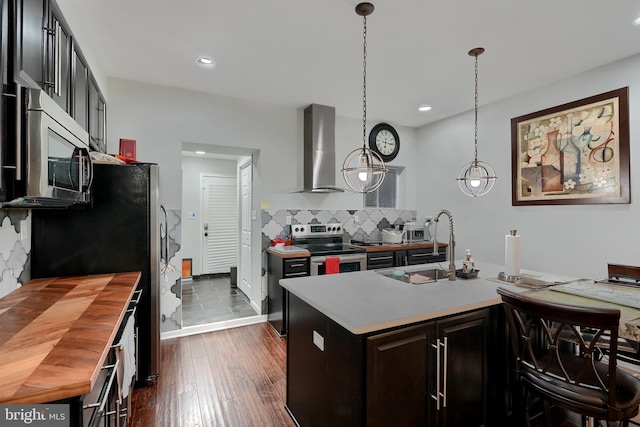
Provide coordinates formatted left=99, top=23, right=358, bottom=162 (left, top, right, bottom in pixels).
left=238, top=163, right=255, bottom=300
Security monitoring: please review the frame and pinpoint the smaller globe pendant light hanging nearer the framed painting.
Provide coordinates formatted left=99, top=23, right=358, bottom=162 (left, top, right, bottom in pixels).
left=456, top=47, right=497, bottom=197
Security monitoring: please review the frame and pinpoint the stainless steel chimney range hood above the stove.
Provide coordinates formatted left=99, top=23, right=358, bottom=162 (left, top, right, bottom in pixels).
left=299, top=104, right=344, bottom=193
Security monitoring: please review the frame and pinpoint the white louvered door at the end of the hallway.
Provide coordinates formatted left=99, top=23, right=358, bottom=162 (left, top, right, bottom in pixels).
left=202, top=175, right=238, bottom=274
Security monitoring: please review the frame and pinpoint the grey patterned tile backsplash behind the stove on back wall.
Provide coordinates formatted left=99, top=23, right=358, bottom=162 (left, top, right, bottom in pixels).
left=261, top=209, right=416, bottom=247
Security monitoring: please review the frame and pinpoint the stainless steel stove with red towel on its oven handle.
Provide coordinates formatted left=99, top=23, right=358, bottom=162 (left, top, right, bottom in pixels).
left=291, top=223, right=367, bottom=276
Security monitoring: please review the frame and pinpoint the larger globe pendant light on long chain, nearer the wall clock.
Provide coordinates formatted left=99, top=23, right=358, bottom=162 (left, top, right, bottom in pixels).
left=342, top=3, right=387, bottom=193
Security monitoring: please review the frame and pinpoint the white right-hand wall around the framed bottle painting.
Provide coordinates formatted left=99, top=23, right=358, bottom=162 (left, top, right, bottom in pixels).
left=416, top=56, right=640, bottom=278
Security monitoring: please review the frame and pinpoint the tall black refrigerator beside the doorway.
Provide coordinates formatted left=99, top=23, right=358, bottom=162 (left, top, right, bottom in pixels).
left=31, top=163, right=167, bottom=386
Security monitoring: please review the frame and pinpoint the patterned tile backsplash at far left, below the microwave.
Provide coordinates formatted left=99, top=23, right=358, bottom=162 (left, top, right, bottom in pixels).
left=0, top=209, right=31, bottom=298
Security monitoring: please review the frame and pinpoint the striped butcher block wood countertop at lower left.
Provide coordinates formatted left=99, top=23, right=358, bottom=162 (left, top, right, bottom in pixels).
left=0, top=272, right=140, bottom=403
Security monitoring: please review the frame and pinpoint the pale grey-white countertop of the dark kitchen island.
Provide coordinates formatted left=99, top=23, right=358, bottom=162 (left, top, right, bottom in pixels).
left=280, top=261, right=568, bottom=335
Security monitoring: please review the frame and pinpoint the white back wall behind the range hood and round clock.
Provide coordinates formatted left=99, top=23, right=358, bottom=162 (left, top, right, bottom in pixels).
left=107, top=78, right=417, bottom=310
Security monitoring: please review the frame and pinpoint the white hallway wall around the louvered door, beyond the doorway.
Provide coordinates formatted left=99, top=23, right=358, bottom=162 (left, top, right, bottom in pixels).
left=182, top=157, right=238, bottom=276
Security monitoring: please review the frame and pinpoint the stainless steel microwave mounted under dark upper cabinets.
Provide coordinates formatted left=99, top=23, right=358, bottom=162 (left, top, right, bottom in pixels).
left=2, top=88, right=93, bottom=208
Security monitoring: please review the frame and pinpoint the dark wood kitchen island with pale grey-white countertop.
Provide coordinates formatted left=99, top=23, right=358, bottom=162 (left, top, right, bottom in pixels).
left=280, top=262, right=556, bottom=426
